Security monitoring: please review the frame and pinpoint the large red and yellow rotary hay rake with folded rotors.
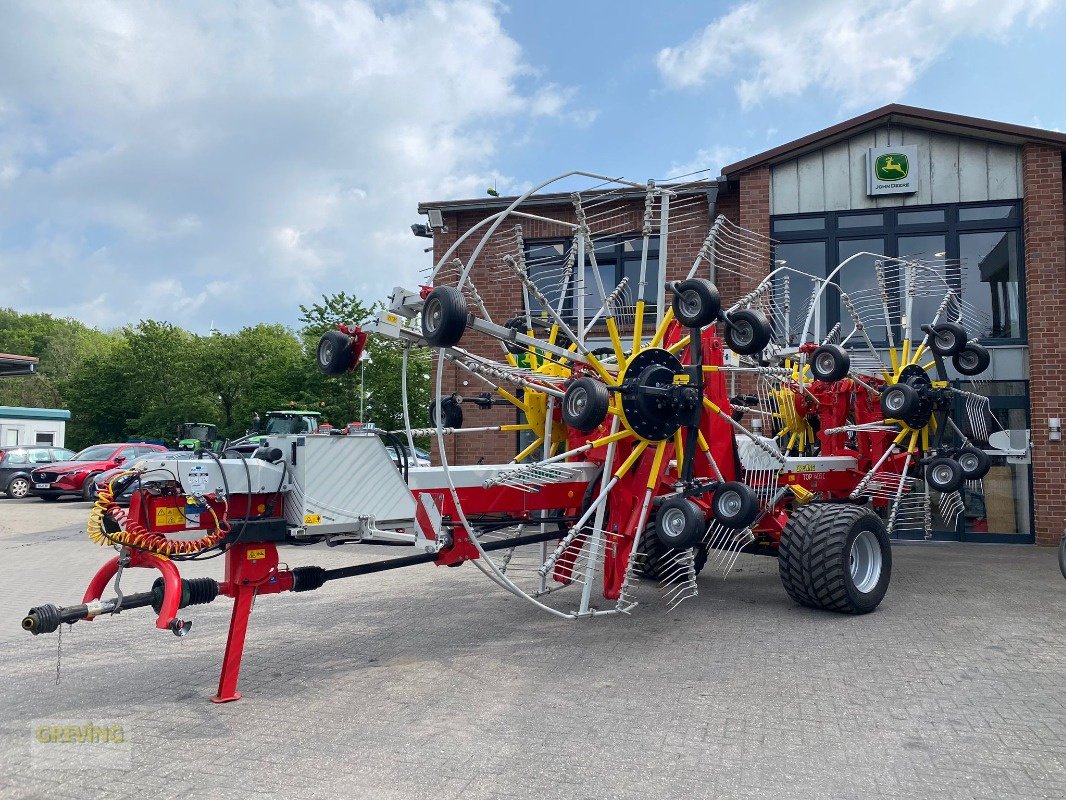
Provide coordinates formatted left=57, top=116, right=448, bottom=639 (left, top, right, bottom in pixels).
left=22, top=173, right=989, bottom=702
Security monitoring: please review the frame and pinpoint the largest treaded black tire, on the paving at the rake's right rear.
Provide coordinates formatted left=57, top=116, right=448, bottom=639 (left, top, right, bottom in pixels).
left=777, top=503, right=892, bottom=614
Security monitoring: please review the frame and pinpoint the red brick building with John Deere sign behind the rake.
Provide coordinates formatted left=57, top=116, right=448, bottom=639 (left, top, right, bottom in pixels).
left=419, top=105, right=1066, bottom=544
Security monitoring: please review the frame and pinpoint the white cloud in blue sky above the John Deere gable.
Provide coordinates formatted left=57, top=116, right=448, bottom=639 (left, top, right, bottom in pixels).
left=658, top=0, right=1053, bottom=108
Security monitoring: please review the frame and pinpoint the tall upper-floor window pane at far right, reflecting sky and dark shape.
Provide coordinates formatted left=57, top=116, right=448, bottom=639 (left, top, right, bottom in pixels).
left=958, top=231, right=1021, bottom=339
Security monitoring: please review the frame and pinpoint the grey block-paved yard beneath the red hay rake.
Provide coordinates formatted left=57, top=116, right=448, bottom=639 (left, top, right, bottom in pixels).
left=0, top=499, right=1066, bottom=800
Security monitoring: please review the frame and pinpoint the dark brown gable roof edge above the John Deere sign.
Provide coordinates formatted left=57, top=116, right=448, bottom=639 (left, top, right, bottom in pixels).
left=722, top=103, right=1066, bottom=178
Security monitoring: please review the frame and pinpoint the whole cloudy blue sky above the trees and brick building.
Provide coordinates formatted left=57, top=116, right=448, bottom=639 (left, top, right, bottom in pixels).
left=0, top=0, right=1066, bottom=333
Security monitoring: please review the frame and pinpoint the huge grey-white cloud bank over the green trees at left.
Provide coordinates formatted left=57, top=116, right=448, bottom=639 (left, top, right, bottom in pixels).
left=0, top=0, right=591, bottom=330
